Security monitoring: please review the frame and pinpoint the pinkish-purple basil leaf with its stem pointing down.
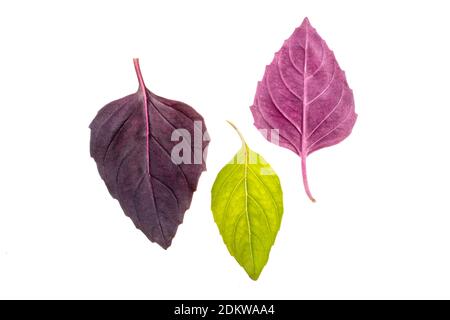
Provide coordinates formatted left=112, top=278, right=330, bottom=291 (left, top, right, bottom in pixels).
left=250, top=18, right=357, bottom=201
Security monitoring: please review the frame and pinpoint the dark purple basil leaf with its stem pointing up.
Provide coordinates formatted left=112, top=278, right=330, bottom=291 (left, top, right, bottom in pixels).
left=90, top=59, right=208, bottom=249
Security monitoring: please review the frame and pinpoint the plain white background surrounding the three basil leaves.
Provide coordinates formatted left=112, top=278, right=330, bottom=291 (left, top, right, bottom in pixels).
left=0, top=0, right=450, bottom=299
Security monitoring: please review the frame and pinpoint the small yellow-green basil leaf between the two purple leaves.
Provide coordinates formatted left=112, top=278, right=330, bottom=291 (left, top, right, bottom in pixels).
left=211, top=123, right=283, bottom=280
